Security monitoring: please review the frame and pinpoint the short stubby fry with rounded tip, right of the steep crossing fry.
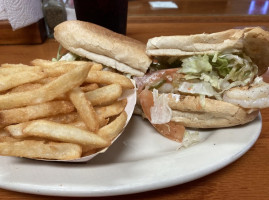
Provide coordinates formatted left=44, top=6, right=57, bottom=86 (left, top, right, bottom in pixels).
left=85, top=84, right=122, bottom=106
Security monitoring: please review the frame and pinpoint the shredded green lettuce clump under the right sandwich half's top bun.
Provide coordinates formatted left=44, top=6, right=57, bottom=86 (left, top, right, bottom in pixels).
left=176, top=53, right=258, bottom=99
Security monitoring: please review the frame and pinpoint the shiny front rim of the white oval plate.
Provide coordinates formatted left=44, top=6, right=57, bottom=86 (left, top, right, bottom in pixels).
left=0, top=112, right=262, bottom=197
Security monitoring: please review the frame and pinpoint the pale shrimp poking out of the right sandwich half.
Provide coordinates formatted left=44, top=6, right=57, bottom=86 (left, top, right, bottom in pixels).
left=223, top=78, right=269, bottom=109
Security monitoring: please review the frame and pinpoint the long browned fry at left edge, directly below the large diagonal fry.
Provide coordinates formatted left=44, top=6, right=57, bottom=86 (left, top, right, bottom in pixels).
left=0, top=101, right=75, bottom=126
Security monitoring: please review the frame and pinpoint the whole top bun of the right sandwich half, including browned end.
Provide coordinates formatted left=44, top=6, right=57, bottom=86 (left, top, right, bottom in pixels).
left=146, top=27, right=269, bottom=74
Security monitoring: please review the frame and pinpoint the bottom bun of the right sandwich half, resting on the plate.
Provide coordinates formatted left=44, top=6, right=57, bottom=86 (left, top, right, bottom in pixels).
left=168, top=95, right=259, bottom=128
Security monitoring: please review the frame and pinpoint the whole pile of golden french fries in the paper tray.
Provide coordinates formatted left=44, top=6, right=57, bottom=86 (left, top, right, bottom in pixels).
left=0, top=59, right=134, bottom=160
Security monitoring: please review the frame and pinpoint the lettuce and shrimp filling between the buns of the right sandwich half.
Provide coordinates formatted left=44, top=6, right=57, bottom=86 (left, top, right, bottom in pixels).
left=135, top=53, right=269, bottom=127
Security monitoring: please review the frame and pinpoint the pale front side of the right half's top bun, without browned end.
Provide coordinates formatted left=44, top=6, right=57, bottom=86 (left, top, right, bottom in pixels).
left=147, top=29, right=244, bottom=56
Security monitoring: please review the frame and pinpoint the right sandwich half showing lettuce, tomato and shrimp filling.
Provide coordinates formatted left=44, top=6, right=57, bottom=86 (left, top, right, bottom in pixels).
left=135, top=28, right=269, bottom=142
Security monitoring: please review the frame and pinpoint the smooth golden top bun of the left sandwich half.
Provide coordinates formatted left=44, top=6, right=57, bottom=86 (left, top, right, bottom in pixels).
left=54, top=21, right=151, bottom=76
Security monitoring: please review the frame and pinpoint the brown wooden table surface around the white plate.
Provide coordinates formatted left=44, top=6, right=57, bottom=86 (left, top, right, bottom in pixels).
left=0, top=1, right=269, bottom=200
